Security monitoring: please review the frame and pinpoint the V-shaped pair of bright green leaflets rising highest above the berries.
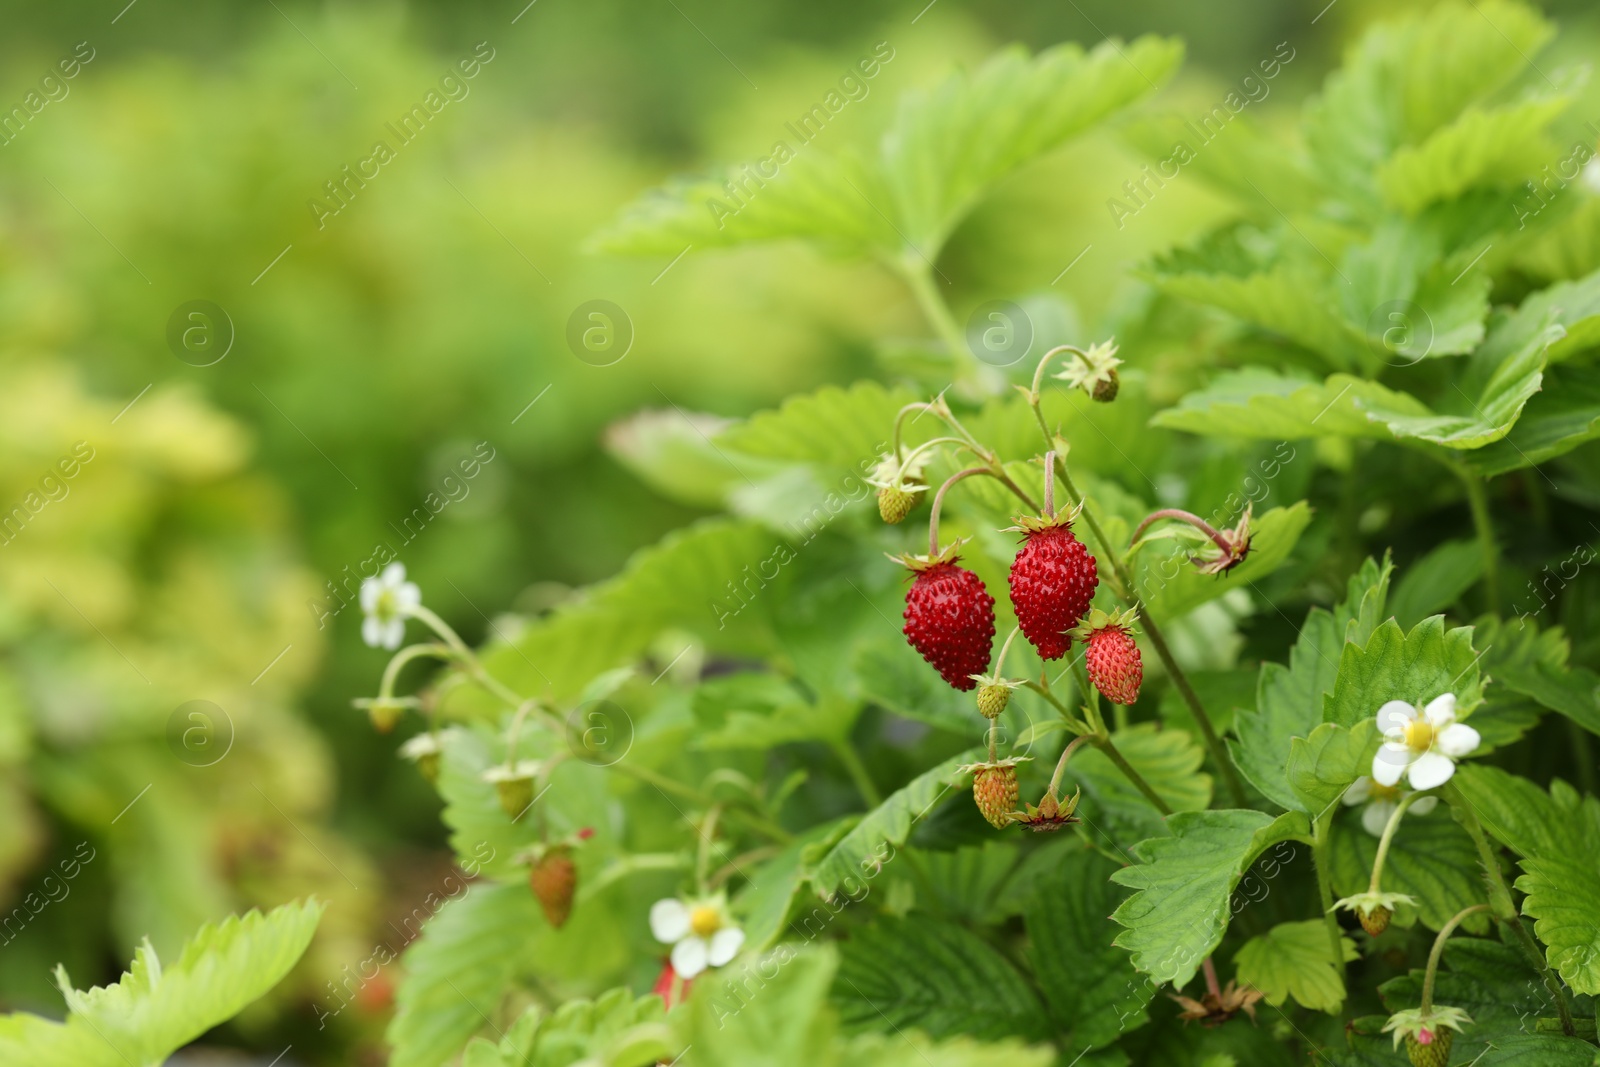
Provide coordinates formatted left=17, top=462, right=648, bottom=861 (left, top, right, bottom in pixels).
left=592, top=37, right=1182, bottom=270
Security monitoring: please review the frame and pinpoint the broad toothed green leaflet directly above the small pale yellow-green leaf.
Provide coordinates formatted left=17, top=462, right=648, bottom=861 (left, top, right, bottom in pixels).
left=1112, top=811, right=1309, bottom=987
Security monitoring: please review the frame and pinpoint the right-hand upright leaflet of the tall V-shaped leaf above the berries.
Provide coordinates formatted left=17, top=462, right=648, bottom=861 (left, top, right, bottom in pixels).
left=882, top=37, right=1182, bottom=261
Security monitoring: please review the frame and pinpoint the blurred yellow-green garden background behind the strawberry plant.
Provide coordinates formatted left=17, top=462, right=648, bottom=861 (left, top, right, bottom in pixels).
left=9, top=0, right=1600, bottom=1062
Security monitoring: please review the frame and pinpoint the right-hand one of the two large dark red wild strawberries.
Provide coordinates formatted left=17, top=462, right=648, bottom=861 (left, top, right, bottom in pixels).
left=1011, top=517, right=1099, bottom=659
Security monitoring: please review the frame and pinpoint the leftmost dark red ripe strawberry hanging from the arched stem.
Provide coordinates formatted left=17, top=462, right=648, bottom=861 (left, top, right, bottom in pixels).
left=904, top=560, right=995, bottom=691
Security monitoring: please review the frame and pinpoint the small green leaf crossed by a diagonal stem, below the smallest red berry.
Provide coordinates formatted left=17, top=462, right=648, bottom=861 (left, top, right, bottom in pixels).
left=1067, top=723, right=1211, bottom=843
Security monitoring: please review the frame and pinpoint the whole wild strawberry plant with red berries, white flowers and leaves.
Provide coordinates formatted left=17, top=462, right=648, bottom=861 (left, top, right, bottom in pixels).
left=0, top=0, right=1600, bottom=1067
